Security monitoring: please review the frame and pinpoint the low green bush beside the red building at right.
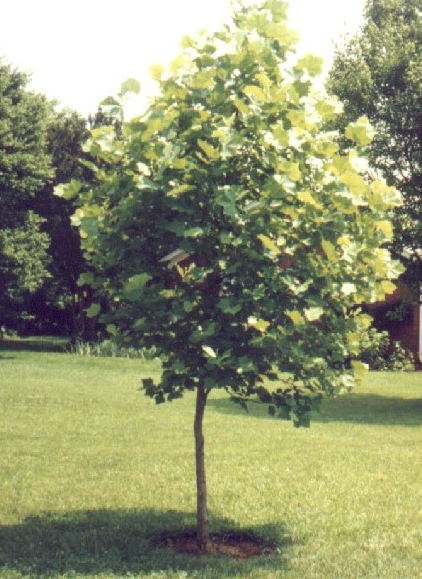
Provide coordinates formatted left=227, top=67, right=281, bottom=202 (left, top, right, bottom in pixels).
left=359, top=328, right=415, bottom=372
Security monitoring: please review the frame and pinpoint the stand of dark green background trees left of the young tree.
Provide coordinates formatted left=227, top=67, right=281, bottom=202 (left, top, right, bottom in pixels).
left=0, top=61, right=115, bottom=339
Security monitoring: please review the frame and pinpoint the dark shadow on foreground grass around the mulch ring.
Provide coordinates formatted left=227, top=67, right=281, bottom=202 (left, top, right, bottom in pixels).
left=0, top=510, right=291, bottom=579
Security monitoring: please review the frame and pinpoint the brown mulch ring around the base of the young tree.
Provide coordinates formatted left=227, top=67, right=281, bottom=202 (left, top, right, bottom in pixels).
left=153, top=531, right=278, bottom=559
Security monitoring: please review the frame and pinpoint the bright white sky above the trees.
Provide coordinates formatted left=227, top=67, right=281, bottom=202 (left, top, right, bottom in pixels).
left=0, top=0, right=364, bottom=115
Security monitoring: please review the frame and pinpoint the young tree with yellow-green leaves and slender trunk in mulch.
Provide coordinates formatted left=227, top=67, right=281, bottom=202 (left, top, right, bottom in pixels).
left=58, top=0, right=400, bottom=551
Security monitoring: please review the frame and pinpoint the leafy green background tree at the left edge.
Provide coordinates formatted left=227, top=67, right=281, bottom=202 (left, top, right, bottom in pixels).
left=0, top=61, right=52, bottom=320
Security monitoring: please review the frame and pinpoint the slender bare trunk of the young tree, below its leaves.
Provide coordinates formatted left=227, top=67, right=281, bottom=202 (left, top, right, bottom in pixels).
left=194, top=384, right=209, bottom=553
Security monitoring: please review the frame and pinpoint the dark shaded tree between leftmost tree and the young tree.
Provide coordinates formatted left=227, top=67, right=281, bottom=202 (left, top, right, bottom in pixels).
left=34, top=110, right=92, bottom=339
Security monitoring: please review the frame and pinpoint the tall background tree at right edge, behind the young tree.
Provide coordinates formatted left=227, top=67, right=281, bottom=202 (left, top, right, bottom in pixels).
left=328, top=0, right=422, bottom=285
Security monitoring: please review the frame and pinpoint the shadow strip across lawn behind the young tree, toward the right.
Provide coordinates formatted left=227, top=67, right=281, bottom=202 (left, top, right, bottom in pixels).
left=208, top=393, right=422, bottom=427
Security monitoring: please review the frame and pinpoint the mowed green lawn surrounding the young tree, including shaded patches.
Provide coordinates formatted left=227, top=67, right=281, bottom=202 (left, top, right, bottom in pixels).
left=0, top=342, right=422, bottom=579
